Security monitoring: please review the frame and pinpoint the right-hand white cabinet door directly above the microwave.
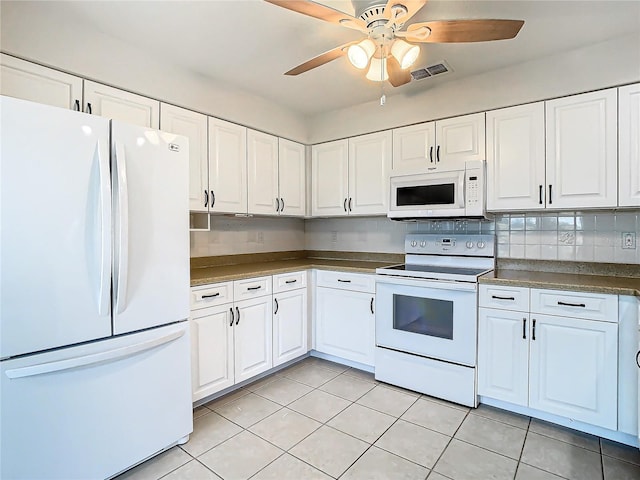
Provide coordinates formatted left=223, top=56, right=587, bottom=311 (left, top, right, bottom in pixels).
left=435, top=113, right=486, bottom=167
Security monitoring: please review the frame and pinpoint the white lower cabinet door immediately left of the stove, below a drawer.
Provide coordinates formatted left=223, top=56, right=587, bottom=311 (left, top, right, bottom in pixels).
left=315, top=287, right=375, bottom=365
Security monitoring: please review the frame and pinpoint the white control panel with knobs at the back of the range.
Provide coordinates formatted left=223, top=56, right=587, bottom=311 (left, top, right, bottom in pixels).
left=404, top=233, right=495, bottom=257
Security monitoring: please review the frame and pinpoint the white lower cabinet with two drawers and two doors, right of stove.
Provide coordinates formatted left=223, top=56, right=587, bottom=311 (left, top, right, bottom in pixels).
left=478, top=285, right=618, bottom=430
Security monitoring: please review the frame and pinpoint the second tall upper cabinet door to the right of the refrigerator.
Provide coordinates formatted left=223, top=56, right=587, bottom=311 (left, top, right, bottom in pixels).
left=209, top=117, right=247, bottom=213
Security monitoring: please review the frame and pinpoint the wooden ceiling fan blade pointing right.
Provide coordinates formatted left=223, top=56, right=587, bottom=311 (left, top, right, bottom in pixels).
left=402, top=19, right=524, bottom=43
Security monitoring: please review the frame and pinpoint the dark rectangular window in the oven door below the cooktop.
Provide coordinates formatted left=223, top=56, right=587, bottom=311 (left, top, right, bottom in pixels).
left=393, top=295, right=453, bottom=340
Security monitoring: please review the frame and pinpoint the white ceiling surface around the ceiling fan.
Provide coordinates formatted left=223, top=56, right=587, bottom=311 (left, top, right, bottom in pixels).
left=3, top=0, right=640, bottom=115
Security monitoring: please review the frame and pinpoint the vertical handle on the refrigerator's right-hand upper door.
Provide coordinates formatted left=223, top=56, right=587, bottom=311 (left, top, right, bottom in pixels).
left=115, top=144, right=129, bottom=313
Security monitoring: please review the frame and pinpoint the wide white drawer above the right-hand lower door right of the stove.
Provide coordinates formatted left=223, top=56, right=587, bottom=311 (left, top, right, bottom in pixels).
left=531, top=288, right=618, bottom=323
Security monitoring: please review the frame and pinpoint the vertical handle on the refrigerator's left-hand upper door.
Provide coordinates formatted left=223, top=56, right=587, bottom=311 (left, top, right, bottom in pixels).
left=96, top=142, right=111, bottom=316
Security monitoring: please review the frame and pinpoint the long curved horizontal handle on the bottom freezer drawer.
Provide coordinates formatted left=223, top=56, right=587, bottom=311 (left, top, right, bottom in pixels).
left=5, top=329, right=185, bottom=379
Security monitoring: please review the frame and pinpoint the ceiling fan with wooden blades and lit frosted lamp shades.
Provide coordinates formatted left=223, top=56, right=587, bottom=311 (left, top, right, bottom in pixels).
left=265, top=0, right=524, bottom=87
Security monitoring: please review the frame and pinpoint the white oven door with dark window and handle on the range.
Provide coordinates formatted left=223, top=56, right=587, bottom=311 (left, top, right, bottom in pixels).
left=376, top=277, right=477, bottom=367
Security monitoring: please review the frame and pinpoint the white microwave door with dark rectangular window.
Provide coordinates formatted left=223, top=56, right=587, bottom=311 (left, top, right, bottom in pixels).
left=389, top=170, right=465, bottom=218
